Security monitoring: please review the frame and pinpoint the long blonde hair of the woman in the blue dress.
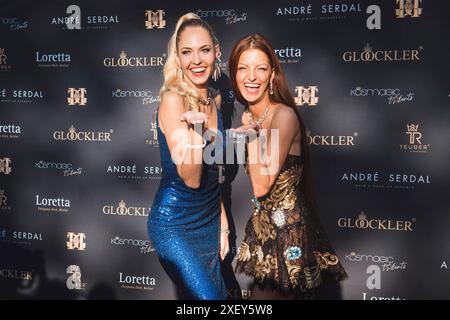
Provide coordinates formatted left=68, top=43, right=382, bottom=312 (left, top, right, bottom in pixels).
left=159, top=12, right=219, bottom=111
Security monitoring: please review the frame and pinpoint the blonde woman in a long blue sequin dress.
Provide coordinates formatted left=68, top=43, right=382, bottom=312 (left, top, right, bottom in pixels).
left=148, top=13, right=229, bottom=300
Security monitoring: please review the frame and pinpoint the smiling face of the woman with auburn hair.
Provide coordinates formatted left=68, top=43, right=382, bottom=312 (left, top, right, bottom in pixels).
left=236, top=49, right=275, bottom=104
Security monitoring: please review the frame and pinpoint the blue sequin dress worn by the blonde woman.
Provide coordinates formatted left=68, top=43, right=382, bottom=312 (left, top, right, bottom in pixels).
left=148, top=100, right=227, bottom=300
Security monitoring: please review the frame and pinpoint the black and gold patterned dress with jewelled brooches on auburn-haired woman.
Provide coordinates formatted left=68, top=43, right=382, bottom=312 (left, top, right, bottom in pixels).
left=236, top=155, right=347, bottom=292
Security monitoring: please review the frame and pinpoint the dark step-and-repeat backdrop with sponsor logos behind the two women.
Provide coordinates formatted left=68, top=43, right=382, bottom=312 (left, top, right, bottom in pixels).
left=0, top=0, right=450, bottom=300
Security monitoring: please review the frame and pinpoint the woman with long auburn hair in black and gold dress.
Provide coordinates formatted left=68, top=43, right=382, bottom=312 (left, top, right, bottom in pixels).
left=229, top=34, right=347, bottom=297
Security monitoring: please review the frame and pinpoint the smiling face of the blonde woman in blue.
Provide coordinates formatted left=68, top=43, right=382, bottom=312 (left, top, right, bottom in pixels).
left=177, top=26, right=219, bottom=88
